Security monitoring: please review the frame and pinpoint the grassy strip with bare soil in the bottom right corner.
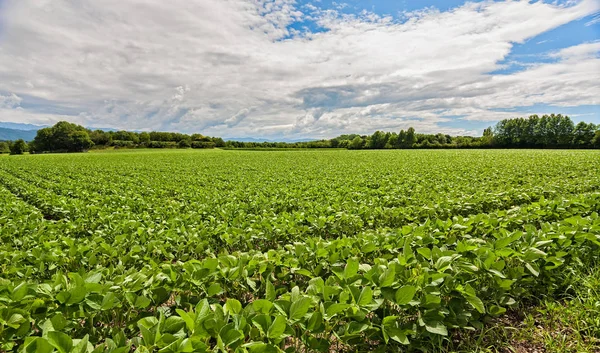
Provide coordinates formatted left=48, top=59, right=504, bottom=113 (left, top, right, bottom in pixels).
left=450, top=263, right=600, bottom=353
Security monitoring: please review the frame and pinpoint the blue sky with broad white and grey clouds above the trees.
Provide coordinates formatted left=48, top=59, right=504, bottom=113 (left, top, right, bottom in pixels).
left=0, top=0, right=600, bottom=140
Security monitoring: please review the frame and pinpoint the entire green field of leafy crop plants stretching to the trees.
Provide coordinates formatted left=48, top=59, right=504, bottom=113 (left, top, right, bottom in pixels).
left=0, top=150, right=600, bottom=353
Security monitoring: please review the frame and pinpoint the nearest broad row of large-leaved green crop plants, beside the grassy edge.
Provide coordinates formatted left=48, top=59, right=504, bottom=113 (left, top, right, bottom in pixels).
left=0, top=194, right=600, bottom=352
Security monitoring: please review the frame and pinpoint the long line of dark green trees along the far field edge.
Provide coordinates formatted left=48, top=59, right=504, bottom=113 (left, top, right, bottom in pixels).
left=0, top=114, right=600, bottom=154
